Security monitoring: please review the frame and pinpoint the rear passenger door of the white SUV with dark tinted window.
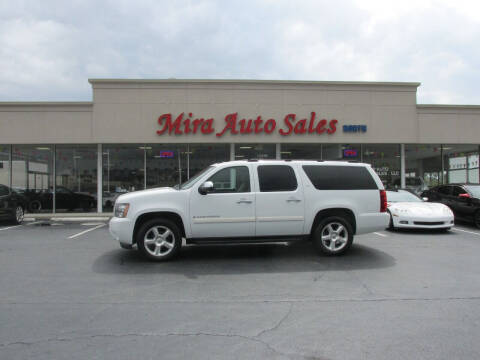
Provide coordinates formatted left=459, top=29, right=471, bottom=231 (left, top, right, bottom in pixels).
left=255, top=165, right=305, bottom=237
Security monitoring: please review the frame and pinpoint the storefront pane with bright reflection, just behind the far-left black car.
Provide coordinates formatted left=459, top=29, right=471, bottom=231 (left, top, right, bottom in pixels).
left=12, top=145, right=53, bottom=213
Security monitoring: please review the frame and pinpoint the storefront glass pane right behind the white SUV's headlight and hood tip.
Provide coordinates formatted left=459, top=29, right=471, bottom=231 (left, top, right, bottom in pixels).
left=102, top=144, right=145, bottom=211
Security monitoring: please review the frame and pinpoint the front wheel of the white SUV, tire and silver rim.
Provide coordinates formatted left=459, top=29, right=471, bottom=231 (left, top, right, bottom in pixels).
left=135, top=218, right=182, bottom=261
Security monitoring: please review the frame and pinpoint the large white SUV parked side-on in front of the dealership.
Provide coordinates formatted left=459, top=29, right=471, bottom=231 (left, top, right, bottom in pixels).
left=110, top=160, right=389, bottom=261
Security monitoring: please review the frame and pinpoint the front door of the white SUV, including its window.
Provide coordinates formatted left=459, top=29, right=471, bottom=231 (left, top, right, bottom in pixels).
left=190, top=166, right=255, bottom=238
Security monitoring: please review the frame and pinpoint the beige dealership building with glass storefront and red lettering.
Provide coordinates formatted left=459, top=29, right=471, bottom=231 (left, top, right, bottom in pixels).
left=0, top=79, right=480, bottom=213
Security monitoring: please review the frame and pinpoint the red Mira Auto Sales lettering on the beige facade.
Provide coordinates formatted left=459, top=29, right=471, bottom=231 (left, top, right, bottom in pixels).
left=157, top=111, right=338, bottom=137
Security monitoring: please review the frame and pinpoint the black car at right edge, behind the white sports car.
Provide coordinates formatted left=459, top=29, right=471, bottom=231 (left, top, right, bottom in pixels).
left=422, top=184, right=480, bottom=228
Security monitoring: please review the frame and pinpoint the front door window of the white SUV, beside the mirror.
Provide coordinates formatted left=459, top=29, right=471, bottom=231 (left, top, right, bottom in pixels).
left=208, top=166, right=250, bottom=193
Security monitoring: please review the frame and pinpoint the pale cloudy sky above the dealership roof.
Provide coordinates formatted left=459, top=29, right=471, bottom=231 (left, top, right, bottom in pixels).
left=0, top=0, right=480, bottom=105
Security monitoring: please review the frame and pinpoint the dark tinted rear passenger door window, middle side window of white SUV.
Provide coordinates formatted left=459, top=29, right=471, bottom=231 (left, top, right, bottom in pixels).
left=257, top=165, right=297, bottom=192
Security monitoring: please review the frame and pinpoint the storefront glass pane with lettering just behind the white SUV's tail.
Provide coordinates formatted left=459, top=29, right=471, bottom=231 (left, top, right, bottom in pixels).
left=362, top=144, right=400, bottom=189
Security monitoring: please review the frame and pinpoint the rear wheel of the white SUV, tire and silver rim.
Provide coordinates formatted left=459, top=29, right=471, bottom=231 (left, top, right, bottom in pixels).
left=313, top=216, right=353, bottom=256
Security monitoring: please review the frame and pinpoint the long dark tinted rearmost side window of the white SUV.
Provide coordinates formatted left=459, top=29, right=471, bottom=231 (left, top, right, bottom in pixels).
left=303, top=165, right=378, bottom=190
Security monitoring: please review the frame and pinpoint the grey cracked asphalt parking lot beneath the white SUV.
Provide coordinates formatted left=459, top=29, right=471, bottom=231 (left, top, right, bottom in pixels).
left=0, top=222, right=480, bottom=359
